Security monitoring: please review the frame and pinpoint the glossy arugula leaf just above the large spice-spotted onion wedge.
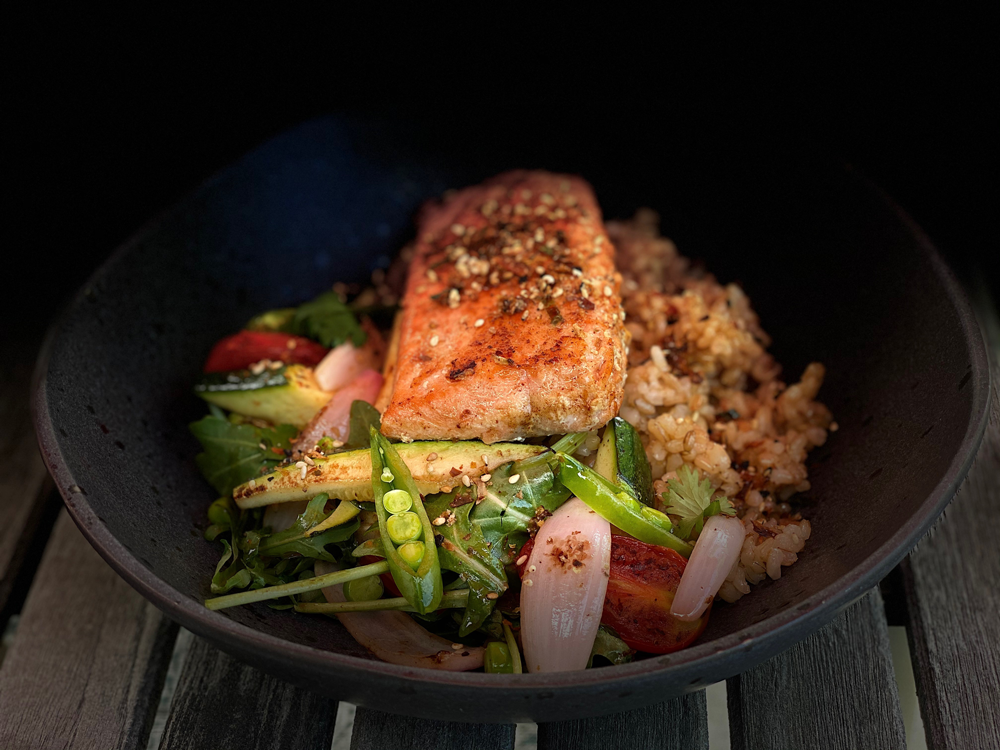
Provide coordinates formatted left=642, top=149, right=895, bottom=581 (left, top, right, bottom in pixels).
left=468, top=453, right=570, bottom=565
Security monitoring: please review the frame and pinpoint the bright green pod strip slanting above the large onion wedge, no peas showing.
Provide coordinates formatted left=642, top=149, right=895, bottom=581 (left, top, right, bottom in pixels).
left=556, top=453, right=692, bottom=557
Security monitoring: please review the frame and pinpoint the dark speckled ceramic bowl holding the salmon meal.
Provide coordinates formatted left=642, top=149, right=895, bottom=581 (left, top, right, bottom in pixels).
left=34, top=119, right=989, bottom=721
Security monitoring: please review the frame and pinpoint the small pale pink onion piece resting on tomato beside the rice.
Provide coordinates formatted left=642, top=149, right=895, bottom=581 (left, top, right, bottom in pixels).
left=670, top=516, right=746, bottom=622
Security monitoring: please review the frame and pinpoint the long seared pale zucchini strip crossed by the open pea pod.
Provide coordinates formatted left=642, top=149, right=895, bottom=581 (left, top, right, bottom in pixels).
left=233, top=440, right=548, bottom=510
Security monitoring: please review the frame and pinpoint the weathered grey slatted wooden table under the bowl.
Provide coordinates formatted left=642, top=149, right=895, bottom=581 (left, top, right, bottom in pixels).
left=0, top=284, right=1000, bottom=750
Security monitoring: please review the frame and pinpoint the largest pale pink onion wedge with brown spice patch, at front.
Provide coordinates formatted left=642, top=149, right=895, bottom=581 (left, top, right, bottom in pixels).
left=521, top=497, right=611, bottom=673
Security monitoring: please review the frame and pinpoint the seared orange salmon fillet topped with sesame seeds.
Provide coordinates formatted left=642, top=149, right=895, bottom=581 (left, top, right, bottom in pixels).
left=382, top=171, right=628, bottom=443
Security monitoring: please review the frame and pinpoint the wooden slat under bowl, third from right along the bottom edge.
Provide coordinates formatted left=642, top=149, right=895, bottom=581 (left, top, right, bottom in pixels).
left=538, top=690, right=708, bottom=750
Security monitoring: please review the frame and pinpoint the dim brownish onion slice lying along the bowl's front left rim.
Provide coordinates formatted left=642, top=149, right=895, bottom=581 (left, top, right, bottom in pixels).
left=316, top=561, right=482, bottom=672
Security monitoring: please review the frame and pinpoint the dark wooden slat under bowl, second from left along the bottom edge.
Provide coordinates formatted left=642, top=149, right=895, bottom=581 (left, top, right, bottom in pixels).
left=160, top=638, right=337, bottom=750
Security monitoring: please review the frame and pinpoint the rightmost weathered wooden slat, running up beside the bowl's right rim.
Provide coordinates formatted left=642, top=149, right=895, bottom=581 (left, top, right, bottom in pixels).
left=903, top=288, right=1000, bottom=748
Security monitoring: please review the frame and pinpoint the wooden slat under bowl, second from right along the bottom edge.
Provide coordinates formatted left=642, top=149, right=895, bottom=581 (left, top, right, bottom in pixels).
left=727, top=588, right=906, bottom=750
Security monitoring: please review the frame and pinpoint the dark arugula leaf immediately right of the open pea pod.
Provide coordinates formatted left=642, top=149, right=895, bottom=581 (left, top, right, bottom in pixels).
left=424, top=492, right=507, bottom=637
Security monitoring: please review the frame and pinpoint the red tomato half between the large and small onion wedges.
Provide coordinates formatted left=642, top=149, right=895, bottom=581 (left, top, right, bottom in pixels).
left=601, top=534, right=709, bottom=654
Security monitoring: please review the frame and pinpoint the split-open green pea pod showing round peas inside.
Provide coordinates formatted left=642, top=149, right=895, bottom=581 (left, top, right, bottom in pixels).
left=369, top=427, right=444, bottom=614
